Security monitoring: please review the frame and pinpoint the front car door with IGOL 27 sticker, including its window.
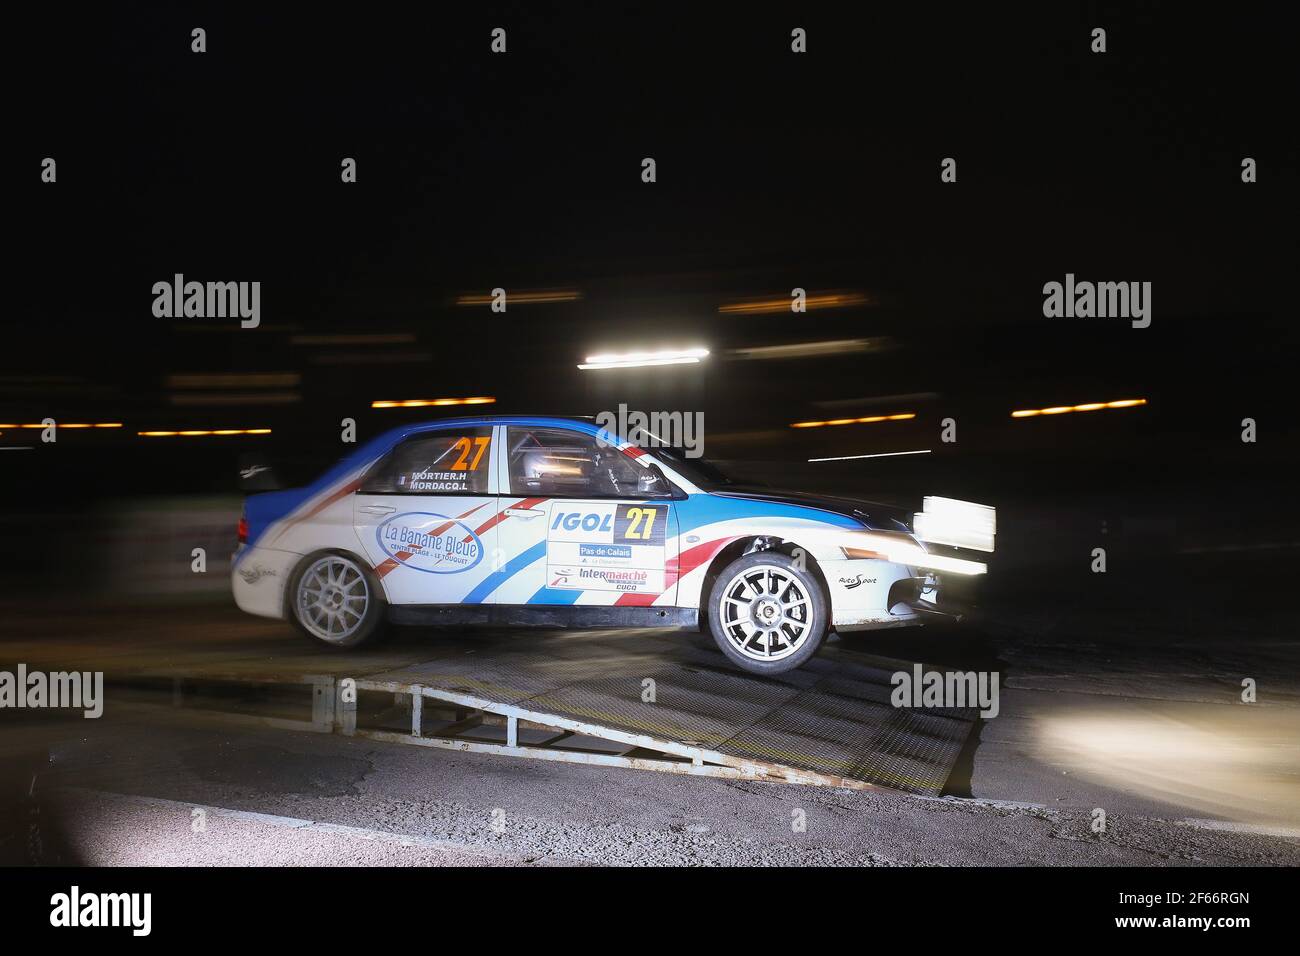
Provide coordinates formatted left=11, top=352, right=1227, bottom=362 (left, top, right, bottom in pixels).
left=491, top=425, right=677, bottom=606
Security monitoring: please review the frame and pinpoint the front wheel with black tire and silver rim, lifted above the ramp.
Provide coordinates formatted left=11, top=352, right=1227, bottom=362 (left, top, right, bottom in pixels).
left=709, top=551, right=829, bottom=674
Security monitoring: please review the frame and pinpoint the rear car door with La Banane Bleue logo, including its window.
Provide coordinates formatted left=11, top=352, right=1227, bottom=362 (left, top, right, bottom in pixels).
left=352, top=425, right=497, bottom=605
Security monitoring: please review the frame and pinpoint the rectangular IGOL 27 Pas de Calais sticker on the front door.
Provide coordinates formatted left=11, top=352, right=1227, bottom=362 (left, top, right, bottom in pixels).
left=546, top=501, right=668, bottom=594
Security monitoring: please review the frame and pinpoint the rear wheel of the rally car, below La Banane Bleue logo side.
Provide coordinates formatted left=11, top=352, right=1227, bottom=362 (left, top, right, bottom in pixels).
left=287, top=551, right=386, bottom=649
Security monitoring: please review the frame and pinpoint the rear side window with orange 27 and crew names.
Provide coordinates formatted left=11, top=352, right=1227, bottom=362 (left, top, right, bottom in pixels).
left=361, top=427, right=491, bottom=494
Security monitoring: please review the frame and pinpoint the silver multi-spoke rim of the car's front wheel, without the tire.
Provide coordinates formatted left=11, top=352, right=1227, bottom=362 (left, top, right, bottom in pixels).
left=718, top=564, right=813, bottom=661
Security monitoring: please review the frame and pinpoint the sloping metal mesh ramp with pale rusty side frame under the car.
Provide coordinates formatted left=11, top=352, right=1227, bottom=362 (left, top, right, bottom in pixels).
left=333, top=630, right=975, bottom=795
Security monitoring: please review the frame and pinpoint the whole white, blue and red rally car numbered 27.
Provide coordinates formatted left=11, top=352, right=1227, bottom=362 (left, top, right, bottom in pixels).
left=231, top=416, right=991, bottom=674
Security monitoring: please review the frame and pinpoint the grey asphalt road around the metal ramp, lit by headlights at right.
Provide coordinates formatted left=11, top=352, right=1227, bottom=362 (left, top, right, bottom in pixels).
left=0, top=580, right=1300, bottom=866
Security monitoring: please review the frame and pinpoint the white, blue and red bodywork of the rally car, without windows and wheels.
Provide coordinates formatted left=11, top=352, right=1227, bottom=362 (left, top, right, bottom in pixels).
left=233, top=416, right=983, bottom=630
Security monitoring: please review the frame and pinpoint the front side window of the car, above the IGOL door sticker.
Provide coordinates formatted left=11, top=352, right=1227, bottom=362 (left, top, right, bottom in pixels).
left=506, top=425, right=671, bottom=498
